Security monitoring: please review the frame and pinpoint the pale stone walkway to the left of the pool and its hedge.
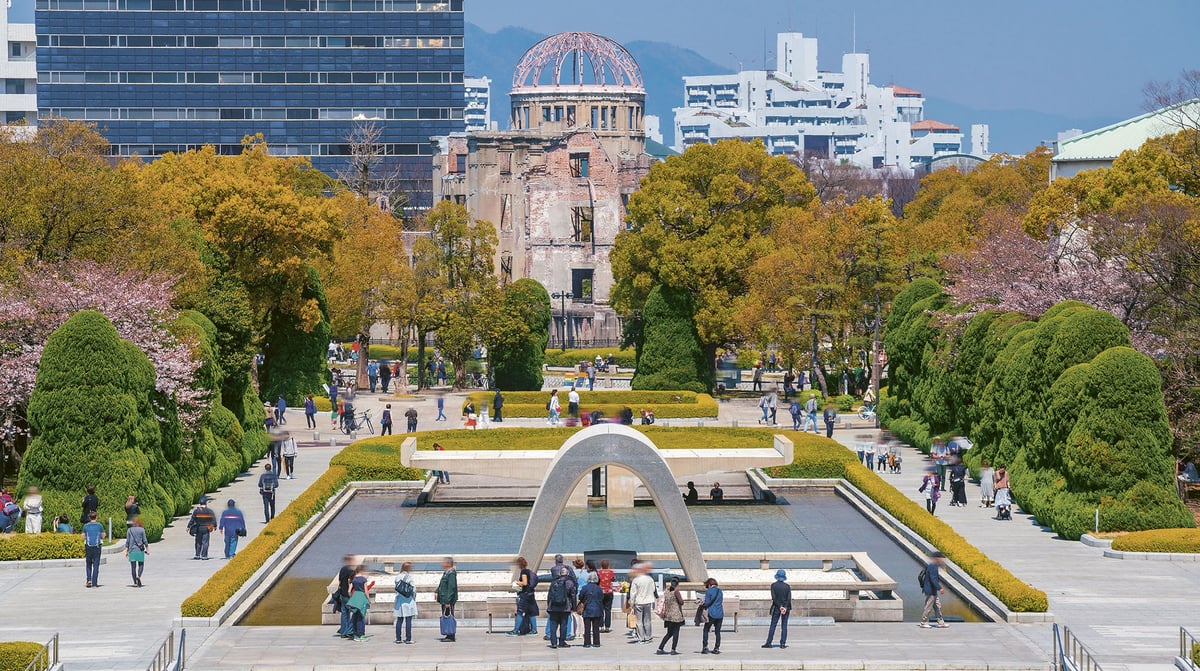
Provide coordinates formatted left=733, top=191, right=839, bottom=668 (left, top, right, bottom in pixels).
left=0, top=420, right=344, bottom=671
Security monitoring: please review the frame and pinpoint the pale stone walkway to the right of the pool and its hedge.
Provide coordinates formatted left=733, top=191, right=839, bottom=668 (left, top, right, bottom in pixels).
left=834, top=430, right=1200, bottom=671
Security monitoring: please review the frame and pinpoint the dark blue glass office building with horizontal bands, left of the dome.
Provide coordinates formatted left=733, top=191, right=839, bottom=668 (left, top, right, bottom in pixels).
left=36, top=0, right=464, bottom=205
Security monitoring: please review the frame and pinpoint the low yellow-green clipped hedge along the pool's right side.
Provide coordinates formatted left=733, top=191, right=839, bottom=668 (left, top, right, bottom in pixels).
left=767, top=436, right=1049, bottom=612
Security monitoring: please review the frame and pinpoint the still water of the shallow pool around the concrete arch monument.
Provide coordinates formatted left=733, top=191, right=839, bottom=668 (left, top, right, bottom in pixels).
left=239, top=491, right=983, bottom=625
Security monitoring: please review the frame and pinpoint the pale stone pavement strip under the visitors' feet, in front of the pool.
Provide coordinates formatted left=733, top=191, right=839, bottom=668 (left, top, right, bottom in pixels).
left=180, top=613, right=1050, bottom=671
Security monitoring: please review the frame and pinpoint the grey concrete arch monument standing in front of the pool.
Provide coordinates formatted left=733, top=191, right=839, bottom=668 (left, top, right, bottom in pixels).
left=511, top=424, right=708, bottom=582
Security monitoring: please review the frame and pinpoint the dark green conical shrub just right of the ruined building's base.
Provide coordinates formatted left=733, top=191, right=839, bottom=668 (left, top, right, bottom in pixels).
left=631, top=286, right=713, bottom=393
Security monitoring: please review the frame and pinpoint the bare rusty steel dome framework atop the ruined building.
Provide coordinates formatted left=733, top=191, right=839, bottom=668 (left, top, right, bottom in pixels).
left=512, top=32, right=643, bottom=90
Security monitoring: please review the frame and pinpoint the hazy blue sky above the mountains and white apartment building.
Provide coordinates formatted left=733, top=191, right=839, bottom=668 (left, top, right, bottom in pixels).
left=466, top=0, right=1200, bottom=116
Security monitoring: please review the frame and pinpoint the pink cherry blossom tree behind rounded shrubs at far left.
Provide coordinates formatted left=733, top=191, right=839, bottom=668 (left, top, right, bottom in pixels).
left=0, top=262, right=208, bottom=426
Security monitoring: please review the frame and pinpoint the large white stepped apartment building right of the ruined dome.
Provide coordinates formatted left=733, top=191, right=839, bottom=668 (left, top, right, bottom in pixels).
left=674, top=32, right=986, bottom=170
